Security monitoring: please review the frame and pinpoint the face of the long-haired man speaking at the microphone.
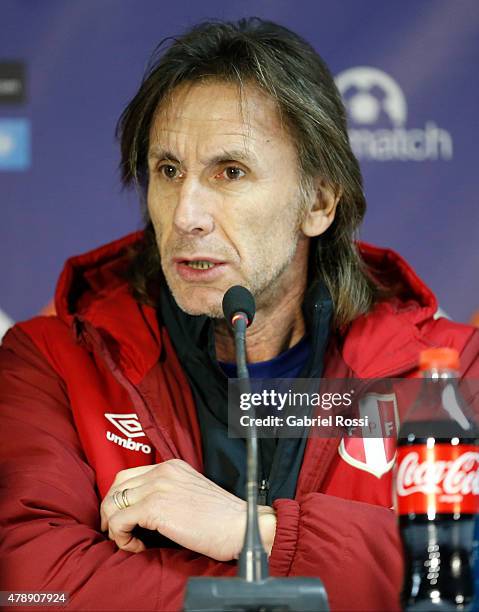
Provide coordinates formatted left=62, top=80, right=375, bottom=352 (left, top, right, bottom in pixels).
left=148, top=82, right=307, bottom=317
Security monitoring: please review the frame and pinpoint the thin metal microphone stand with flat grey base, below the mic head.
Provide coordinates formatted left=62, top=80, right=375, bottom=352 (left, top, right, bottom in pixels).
left=184, top=311, right=329, bottom=612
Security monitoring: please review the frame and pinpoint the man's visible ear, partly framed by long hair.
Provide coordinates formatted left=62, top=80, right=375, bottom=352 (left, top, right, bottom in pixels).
left=301, top=178, right=342, bottom=238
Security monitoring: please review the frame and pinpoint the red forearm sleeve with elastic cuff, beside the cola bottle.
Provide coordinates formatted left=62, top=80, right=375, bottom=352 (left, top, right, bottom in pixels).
left=270, top=493, right=402, bottom=611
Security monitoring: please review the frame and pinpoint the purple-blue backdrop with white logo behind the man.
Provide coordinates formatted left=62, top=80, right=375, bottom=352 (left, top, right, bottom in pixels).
left=0, top=0, right=479, bottom=330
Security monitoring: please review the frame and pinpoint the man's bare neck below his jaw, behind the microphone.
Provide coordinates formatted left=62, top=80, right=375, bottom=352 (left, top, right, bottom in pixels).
left=215, top=280, right=305, bottom=363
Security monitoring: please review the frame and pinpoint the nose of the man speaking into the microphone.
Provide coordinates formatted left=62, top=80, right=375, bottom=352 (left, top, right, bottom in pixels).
left=174, top=179, right=214, bottom=235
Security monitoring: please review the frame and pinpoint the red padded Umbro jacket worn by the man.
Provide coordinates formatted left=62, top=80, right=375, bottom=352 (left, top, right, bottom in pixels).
left=0, top=234, right=479, bottom=610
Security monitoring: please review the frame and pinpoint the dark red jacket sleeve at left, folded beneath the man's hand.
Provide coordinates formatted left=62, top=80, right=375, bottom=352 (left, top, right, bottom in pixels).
left=0, top=329, right=235, bottom=610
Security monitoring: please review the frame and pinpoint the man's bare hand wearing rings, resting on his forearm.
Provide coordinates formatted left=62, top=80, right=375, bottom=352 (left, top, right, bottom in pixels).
left=100, top=459, right=276, bottom=561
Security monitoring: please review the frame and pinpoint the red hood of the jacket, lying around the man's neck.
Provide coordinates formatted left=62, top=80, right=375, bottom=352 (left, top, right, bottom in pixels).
left=55, top=232, right=437, bottom=379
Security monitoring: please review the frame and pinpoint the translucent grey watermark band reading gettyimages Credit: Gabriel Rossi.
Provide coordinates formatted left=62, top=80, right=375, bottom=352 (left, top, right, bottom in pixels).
left=228, top=378, right=479, bottom=438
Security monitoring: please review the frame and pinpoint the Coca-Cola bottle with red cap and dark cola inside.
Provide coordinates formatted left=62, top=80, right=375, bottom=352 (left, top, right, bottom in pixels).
left=395, top=348, right=479, bottom=610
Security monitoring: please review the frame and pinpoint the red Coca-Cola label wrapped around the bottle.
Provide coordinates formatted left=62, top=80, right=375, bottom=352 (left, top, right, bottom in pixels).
left=396, top=444, right=479, bottom=516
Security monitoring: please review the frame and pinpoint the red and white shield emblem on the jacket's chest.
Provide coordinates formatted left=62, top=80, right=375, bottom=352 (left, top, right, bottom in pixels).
left=338, top=393, right=399, bottom=478
